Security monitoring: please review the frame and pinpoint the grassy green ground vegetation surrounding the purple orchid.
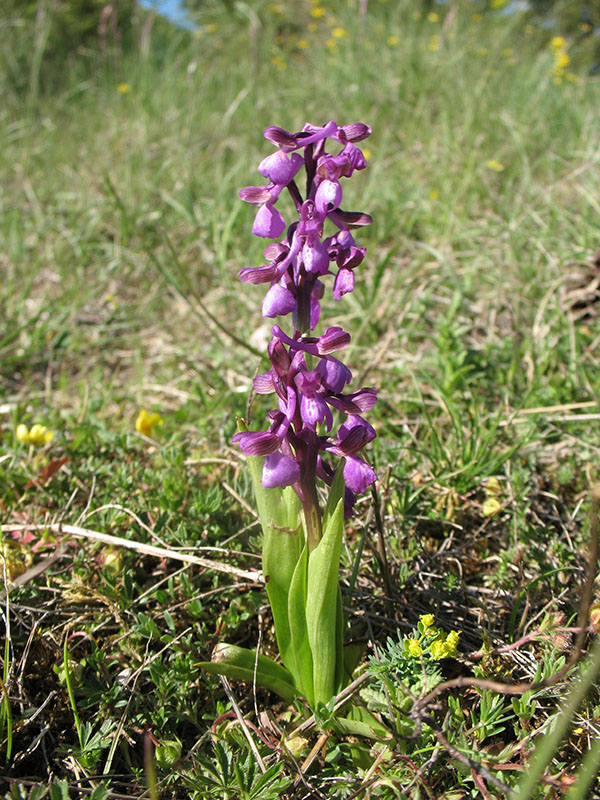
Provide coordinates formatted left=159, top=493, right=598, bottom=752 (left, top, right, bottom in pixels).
left=0, top=0, right=600, bottom=800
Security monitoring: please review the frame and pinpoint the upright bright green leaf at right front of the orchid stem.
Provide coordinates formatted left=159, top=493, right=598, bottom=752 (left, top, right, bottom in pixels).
left=306, top=494, right=344, bottom=703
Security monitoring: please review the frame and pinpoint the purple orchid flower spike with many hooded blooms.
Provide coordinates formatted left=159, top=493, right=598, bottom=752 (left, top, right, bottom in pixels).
left=234, top=121, right=377, bottom=538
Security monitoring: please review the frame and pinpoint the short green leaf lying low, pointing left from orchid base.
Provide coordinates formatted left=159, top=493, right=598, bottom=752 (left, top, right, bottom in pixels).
left=198, top=642, right=298, bottom=703
